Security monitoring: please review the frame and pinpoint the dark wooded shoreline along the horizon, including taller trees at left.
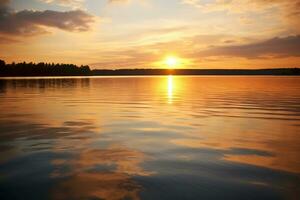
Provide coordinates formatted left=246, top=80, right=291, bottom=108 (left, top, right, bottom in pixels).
left=0, top=60, right=300, bottom=77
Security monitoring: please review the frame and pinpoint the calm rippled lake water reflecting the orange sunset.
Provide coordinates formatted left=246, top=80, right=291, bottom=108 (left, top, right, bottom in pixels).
left=0, top=76, right=300, bottom=200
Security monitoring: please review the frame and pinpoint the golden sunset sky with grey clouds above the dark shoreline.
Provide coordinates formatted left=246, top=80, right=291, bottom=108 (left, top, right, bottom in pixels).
left=0, top=0, right=300, bottom=69
